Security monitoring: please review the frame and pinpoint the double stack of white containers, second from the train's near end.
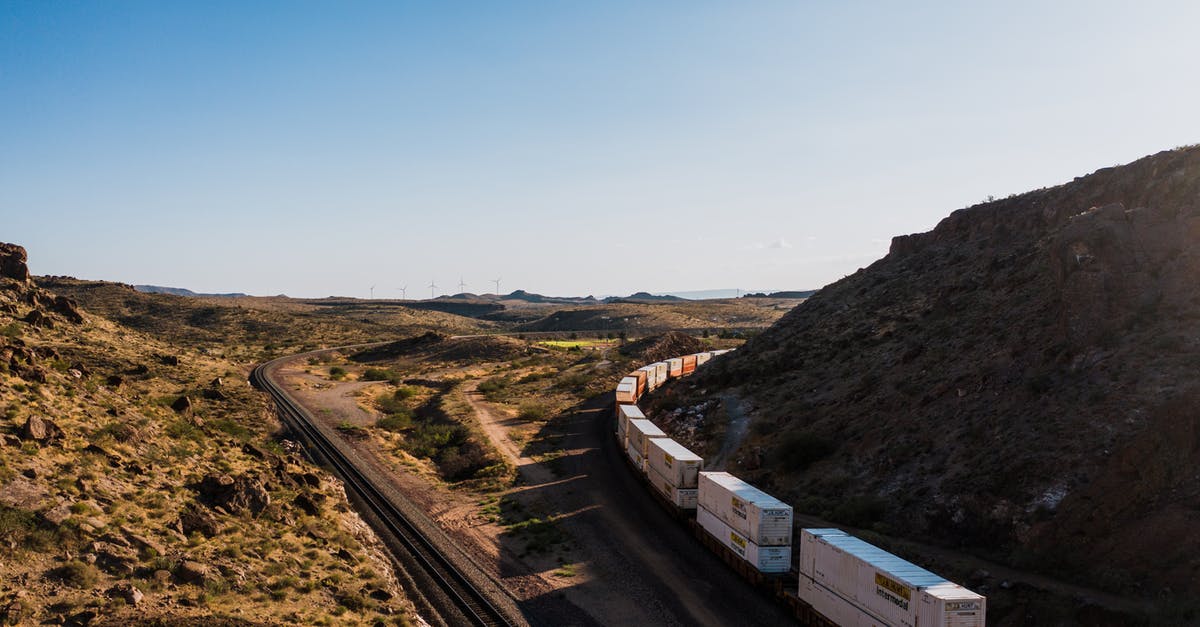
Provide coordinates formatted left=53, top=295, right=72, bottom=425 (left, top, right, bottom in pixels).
left=696, top=472, right=792, bottom=573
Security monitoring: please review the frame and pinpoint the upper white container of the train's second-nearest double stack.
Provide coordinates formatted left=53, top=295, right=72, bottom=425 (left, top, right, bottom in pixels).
left=700, top=472, right=792, bottom=547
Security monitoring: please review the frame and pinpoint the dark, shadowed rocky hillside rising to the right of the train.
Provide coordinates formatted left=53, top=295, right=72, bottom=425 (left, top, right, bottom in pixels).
left=672, top=147, right=1200, bottom=599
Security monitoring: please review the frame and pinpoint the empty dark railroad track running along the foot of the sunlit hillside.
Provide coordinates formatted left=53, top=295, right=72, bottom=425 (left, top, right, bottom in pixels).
left=251, top=357, right=516, bottom=627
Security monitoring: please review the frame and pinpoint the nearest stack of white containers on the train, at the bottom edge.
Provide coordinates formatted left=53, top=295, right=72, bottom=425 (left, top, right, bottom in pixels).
left=798, top=529, right=988, bottom=627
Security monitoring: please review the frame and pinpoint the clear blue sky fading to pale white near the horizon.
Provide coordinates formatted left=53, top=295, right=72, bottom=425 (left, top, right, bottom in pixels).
left=0, top=0, right=1200, bottom=297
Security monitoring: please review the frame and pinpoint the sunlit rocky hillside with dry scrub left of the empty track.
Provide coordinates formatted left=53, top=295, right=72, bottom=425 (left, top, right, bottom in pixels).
left=0, top=244, right=412, bottom=625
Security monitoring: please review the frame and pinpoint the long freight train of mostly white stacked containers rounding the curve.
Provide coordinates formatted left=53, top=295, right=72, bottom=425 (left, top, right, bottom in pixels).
left=613, top=351, right=988, bottom=627
